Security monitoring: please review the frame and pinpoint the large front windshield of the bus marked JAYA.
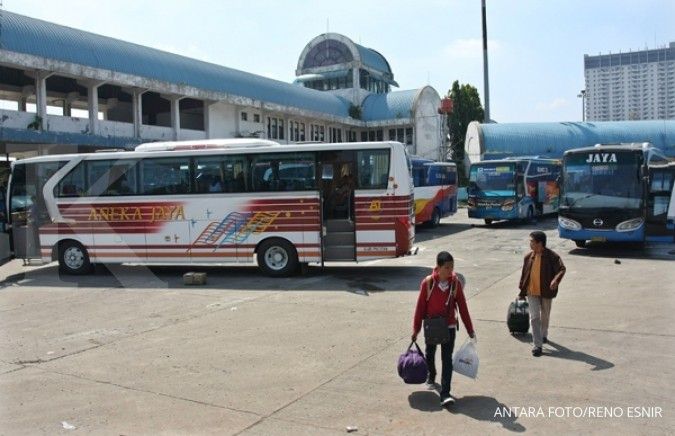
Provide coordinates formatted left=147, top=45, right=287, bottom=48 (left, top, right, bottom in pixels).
left=562, top=152, right=643, bottom=209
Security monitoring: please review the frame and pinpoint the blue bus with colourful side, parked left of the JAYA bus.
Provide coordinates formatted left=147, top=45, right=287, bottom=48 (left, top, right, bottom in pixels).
left=467, top=158, right=560, bottom=225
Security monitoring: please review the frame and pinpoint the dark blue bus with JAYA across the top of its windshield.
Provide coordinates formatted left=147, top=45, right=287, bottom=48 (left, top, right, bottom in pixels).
left=558, top=143, right=675, bottom=247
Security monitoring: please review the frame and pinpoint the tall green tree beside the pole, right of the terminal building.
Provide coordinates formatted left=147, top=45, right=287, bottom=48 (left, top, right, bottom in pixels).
left=448, top=80, right=485, bottom=186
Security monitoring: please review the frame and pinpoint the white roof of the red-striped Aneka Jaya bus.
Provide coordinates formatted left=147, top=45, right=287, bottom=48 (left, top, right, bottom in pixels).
left=13, top=139, right=405, bottom=164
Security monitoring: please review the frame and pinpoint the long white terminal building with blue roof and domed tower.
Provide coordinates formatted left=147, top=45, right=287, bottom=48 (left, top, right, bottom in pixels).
left=0, top=11, right=446, bottom=159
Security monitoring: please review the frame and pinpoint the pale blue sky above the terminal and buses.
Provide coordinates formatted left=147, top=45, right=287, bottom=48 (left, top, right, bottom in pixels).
left=5, top=0, right=675, bottom=122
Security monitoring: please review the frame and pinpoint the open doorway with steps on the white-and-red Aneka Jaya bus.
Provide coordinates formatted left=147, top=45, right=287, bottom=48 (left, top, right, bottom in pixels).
left=318, top=151, right=356, bottom=261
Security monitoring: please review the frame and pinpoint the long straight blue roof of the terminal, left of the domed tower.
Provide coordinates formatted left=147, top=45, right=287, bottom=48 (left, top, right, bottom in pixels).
left=0, top=11, right=354, bottom=117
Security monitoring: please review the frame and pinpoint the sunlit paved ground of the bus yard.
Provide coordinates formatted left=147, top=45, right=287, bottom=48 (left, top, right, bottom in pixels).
left=0, top=210, right=675, bottom=435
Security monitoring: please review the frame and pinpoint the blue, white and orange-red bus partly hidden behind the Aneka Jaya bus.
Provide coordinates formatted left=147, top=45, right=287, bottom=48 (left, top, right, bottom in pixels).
left=411, top=157, right=457, bottom=227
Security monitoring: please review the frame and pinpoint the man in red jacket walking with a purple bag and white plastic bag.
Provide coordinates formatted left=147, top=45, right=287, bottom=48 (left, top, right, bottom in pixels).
left=412, top=251, right=476, bottom=406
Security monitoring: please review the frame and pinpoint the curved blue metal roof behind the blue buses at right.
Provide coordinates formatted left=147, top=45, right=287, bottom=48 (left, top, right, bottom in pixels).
left=479, top=120, right=675, bottom=159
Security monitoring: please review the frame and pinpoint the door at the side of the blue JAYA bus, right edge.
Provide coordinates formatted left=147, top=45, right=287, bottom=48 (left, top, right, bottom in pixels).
left=645, top=165, right=675, bottom=242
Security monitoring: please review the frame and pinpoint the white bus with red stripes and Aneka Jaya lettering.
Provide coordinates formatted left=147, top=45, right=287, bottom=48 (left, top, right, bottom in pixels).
left=9, top=140, right=414, bottom=276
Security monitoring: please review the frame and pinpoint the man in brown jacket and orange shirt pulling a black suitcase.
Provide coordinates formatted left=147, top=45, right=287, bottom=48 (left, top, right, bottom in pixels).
left=518, top=231, right=565, bottom=357
